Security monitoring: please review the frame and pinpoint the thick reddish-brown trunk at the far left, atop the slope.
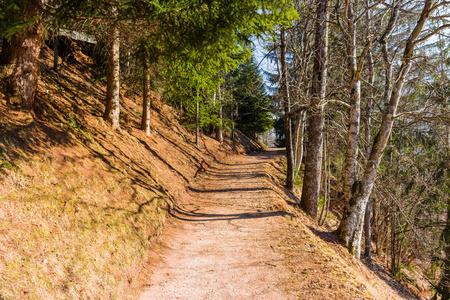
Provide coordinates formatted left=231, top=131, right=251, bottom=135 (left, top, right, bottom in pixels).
left=0, top=0, right=42, bottom=109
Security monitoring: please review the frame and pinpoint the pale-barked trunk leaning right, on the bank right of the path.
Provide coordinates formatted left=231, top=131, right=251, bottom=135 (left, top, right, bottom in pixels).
left=337, top=0, right=434, bottom=259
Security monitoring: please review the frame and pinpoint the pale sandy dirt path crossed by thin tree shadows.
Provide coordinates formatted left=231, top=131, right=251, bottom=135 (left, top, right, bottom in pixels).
left=140, top=152, right=294, bottom=300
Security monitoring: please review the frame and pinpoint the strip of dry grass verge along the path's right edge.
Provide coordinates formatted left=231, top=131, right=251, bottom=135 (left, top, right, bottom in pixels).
left=266, top=154, right=418, bottom=300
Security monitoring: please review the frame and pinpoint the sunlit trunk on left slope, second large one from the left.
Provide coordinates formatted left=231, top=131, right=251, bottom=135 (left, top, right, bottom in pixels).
left=103, top=26, right=120, bottom=130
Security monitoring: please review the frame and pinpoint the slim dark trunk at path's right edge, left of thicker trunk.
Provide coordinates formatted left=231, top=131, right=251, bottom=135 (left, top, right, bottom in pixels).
left=280, top=27, right=294, bottom=191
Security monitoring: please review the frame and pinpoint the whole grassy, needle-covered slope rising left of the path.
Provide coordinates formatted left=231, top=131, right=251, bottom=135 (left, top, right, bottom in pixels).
left=0, top=45, right=260, bottom=299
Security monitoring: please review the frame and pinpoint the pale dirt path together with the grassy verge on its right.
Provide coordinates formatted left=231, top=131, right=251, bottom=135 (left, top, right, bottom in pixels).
left=128, top=150, right=414, bottom=300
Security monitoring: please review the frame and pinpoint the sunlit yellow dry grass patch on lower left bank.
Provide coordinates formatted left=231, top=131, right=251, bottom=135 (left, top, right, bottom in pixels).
left=0, top=127, right=170, bottom=299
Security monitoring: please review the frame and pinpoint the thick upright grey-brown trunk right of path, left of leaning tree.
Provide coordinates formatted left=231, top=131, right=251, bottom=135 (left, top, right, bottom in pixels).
left=301, top=0, right=329, bottom=218
